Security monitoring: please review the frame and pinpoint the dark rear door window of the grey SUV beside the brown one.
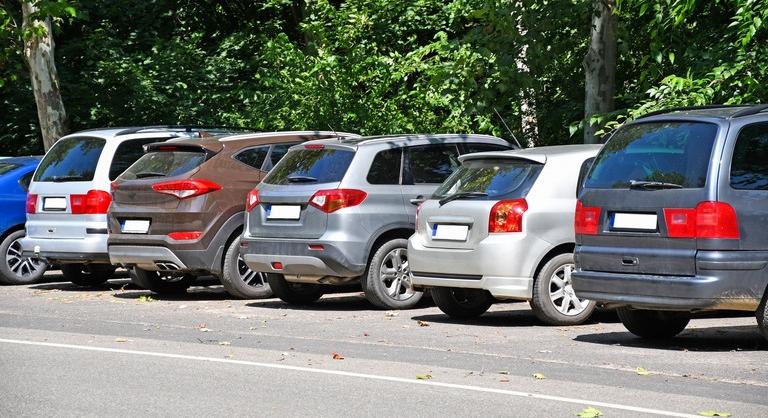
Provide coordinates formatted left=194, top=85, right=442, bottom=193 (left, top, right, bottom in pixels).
left=408, top=144, right=461, bottom=184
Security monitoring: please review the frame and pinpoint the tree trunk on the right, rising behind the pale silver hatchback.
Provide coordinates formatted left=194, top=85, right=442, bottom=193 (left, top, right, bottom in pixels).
left=584, top=0, right=616, bottom=144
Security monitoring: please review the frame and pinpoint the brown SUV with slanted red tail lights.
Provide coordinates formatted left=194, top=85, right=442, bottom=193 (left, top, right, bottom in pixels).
left=108, top=131, right=355, bottom=298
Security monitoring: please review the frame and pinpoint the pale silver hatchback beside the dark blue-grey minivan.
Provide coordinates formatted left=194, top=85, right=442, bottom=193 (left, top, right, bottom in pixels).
left=408, top=145, right=600, bottom=325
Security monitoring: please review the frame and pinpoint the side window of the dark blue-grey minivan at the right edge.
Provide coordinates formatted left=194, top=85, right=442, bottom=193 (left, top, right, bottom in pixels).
left=731, top=124, right=768, bottom=190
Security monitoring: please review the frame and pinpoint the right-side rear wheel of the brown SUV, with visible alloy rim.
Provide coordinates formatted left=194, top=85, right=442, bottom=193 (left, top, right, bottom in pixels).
left=220, top=236, right=274, bottom=299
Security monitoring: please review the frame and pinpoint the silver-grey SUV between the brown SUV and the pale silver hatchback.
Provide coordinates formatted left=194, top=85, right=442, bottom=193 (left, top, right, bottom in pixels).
left=241, top=135, right=510, bottom=309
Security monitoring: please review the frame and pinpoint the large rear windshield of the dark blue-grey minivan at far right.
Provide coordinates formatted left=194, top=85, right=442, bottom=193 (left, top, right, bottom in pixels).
left=584, top=122, right=717, bottom=189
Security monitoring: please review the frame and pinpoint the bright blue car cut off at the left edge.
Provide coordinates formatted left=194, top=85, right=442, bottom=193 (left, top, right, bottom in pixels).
left=0, top=157, right=48, bottom=284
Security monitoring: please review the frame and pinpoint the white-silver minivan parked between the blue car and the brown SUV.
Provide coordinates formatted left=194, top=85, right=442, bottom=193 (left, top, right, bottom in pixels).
left=21, top=126, right=246, bottom=286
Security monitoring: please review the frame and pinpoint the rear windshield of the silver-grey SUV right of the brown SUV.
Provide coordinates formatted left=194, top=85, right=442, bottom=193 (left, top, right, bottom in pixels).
left=264, top=148, right=355, bottom=185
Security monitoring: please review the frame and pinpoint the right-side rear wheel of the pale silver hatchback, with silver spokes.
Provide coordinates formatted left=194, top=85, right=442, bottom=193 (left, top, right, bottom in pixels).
left=530, top=253, right=596, bottom=325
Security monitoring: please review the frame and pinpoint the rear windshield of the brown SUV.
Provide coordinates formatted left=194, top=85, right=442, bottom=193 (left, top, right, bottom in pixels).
left=120, top=151, right=206, bottom=180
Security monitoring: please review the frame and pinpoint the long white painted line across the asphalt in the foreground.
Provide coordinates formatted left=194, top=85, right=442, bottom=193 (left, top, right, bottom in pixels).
left=0, top=338, right=700, bottom=418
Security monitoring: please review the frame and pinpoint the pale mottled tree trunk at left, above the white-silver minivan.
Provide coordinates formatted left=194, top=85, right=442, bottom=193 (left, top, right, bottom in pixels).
left=21, top=1, right=67, bottom=151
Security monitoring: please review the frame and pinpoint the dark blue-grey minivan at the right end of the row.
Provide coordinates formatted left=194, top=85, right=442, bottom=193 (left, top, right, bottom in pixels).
left=572, top=105, right=768, bottom=338
